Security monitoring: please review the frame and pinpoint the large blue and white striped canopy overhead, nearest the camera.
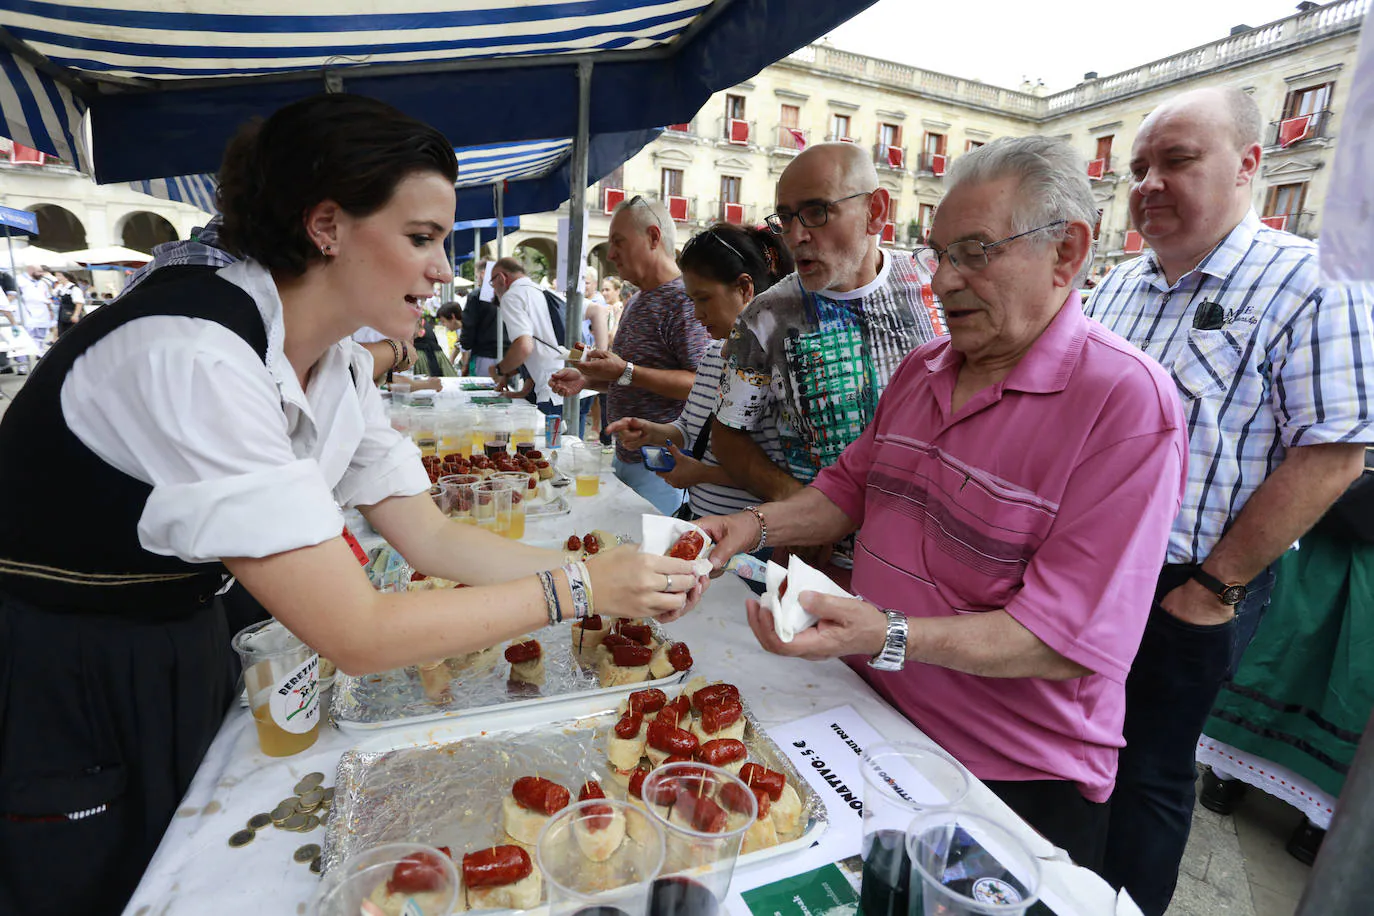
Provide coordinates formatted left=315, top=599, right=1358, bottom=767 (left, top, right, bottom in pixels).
left=0, top=0, right=872, bottom=181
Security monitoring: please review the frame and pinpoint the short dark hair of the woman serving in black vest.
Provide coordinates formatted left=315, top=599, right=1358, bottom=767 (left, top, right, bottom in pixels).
left=217, top=93, right=458, bottom=276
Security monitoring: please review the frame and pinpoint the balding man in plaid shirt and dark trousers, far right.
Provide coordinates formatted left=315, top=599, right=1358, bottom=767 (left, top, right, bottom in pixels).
left=1087, top=89, right=1374, bottom=915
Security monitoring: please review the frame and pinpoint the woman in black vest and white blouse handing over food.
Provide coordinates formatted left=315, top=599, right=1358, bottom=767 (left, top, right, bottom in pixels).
left=0, top=93, right=701, bottom=915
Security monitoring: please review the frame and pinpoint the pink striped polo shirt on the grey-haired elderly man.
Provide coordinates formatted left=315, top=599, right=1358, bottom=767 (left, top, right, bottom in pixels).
left=813, top=293, right=1187, bottom=802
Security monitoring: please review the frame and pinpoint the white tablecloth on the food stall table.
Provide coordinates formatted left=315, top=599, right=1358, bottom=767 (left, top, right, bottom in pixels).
left=125, top=474, right=1117, bottom=916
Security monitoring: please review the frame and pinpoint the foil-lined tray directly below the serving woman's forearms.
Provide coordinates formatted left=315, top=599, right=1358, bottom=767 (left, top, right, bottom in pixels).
left=330, top=619, right=690, bottom=729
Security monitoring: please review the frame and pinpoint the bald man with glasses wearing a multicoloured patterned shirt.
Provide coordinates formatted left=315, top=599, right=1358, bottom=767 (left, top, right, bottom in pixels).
left=710, top=143, right=944, bottom=578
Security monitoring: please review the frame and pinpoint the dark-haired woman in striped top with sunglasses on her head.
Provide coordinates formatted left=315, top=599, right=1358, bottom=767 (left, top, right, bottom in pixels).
left=606, top=222, right=793, bottom=518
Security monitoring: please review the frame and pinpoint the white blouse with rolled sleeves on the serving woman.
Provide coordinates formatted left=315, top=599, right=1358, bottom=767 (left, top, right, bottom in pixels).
left=62, top=254, right=429, bottom=562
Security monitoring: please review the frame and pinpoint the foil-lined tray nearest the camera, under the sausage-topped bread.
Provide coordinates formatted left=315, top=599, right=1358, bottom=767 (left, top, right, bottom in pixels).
left=320, top=691, right=829, bottom=889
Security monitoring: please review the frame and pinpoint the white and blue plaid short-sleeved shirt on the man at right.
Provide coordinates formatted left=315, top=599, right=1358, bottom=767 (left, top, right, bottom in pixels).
left=1087, top=210, right=1374, bottom=563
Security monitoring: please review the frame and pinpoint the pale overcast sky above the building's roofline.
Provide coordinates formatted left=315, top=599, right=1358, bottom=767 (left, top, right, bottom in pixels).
left=829, top=0, right=1313, bottom=91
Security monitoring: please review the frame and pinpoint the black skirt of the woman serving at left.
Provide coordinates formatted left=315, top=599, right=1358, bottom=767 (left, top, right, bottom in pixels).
left=0, top=592, right=235, bottom=916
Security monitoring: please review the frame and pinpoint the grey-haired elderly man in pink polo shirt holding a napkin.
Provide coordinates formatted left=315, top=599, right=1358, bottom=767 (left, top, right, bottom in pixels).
left=701, top=137, right=1187, bottom=868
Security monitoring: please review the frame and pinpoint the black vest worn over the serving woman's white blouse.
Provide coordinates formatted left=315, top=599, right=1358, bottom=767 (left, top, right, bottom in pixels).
left=0, top=266, right=267, bottom=619
